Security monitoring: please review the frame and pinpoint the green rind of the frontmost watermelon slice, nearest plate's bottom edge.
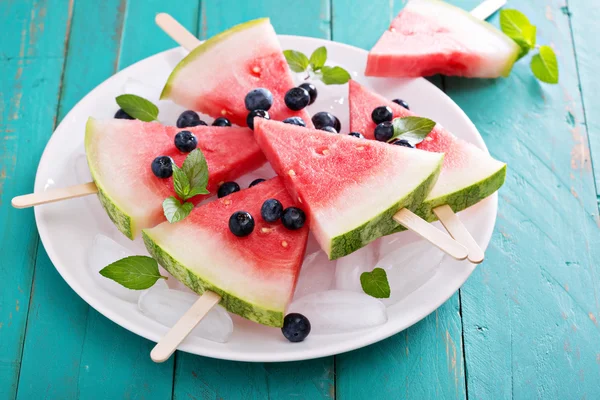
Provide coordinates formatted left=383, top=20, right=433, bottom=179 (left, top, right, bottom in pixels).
left=142, top=229, right=285, bottom=328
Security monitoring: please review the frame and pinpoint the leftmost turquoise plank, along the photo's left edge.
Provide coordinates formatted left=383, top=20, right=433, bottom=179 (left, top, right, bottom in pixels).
left=0, top=0, right=70, bottom=399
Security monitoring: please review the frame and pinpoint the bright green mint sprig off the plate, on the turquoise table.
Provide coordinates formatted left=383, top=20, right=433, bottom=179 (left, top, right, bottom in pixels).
left=500, top=9, right=559, bottom=84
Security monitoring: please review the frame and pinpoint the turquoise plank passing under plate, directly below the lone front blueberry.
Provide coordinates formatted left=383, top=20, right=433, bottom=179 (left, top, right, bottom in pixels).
left=173, top=0, right=334, bottom=399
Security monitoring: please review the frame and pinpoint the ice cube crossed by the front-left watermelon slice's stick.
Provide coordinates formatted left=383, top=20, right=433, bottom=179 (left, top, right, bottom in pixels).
left=138, top=286, right=233, bottom=343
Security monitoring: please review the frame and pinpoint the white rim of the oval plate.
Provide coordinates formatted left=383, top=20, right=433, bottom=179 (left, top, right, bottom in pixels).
left=34, top=35, right=498, bottom=362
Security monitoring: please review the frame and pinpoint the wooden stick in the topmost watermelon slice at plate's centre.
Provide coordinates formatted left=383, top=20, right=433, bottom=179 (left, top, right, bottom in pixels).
left=393, top=208, right=468, bottom=260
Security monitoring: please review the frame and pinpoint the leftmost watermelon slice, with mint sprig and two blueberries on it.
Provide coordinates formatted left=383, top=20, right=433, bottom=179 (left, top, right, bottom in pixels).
left=85, top=118, right=265, bottom=239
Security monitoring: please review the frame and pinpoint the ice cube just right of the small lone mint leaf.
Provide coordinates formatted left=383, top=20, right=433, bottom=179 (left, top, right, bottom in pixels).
left=376, top=240, right=444, bottom=306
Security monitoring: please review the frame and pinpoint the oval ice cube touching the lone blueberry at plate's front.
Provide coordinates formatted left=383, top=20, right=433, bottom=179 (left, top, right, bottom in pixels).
left=289, top=290, right=387, bottom=334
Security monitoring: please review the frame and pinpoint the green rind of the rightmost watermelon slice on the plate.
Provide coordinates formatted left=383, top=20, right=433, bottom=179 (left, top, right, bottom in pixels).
left=392, top=164, right=506, bottom=233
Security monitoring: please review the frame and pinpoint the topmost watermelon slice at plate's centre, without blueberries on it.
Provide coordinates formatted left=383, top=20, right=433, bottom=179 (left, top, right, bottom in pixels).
left=254, top=119, right=443, bottom=260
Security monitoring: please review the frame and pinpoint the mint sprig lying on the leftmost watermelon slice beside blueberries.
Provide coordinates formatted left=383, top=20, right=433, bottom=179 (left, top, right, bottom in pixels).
left=163, top=149, right=210, bottom=224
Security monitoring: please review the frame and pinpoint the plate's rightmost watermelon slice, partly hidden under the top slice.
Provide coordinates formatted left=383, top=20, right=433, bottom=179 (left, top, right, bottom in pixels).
left=348, top=80, right=506, bottom=222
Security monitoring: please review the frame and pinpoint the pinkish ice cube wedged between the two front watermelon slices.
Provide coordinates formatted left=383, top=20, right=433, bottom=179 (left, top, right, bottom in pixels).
left=294, top=249, right=336, bottom=299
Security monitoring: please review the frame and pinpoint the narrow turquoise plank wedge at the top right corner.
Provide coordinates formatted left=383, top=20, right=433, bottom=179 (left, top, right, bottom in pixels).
left=561, top=0, right=600, bottom=199
